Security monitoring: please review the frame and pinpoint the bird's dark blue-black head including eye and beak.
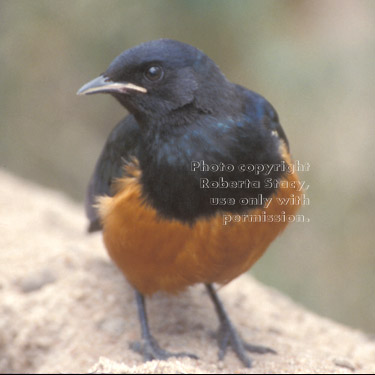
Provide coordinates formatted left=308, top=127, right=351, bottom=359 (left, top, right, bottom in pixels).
left=77, top=39, right=229, bottom=118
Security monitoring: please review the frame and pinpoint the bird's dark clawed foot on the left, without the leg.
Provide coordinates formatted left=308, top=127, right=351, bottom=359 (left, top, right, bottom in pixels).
left=130, top=336, right=198, bottom=362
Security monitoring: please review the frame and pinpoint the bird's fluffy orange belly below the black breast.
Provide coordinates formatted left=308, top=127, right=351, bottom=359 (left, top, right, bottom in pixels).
left=99, top=156, right=302, bottom=295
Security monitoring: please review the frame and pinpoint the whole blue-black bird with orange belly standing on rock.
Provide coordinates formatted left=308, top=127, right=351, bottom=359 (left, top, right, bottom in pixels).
left=77, top=39, right=301, bottom=367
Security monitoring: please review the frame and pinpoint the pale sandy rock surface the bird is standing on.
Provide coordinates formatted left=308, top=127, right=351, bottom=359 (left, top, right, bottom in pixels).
left=0, top=171, right=375, bottom=373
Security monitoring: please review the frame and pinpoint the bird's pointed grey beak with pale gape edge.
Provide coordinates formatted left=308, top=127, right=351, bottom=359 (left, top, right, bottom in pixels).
left=77, top=76, right=147, bottom=95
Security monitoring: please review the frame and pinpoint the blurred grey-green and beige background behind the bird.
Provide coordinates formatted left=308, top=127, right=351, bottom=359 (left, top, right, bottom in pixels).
left=0, top=0, right=375, bottom=333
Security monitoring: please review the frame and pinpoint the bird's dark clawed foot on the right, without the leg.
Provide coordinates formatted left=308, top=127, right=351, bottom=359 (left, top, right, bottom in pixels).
left=217, top=321, right=276, bottom=367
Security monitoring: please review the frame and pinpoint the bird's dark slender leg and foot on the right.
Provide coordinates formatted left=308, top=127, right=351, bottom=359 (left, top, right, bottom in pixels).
left=206, top=284, right=276, bottom=367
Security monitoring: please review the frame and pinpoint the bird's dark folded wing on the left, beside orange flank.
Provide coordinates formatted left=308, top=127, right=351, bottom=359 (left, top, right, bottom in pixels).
left=85, top=115, right=140, bottom=232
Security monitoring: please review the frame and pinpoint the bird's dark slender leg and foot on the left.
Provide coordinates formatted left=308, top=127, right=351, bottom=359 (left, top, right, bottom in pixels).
left=130, top=290, right=198, bottom=361
